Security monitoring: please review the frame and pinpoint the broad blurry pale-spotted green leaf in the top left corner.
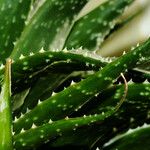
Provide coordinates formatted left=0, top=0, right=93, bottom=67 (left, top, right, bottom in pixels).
left=0, top=0, right=31, bottom=62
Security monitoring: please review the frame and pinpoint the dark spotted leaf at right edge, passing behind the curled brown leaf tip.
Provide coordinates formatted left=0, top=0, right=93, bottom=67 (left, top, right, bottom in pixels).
left=87, top=82, right=150, bottom=148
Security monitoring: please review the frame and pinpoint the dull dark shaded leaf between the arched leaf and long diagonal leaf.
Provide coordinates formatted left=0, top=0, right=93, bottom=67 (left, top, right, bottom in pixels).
left=14, top=67, right=92, bottom=117
